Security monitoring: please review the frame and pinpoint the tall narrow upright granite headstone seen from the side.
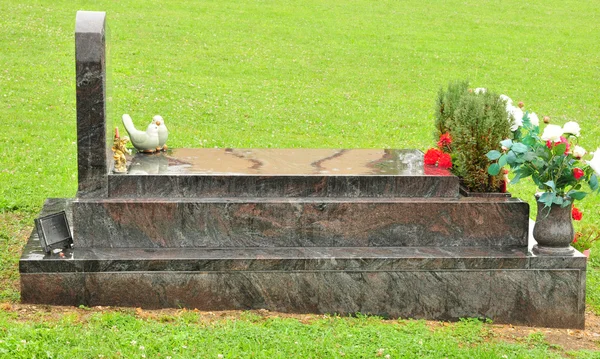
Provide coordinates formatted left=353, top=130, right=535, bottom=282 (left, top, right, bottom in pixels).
left=75, top=11, right=113, bottom=197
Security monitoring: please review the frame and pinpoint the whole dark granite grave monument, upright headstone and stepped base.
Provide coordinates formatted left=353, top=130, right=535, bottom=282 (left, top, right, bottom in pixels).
left=20, top=12, right=586, bottom=328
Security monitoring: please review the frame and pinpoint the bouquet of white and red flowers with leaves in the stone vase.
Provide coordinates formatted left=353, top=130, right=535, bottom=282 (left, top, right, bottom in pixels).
left=487, top=97, right=600, bottom=211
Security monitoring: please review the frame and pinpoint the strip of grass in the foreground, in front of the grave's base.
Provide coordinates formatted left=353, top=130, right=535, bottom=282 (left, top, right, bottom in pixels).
left=0, top=311, right=594, bottom=359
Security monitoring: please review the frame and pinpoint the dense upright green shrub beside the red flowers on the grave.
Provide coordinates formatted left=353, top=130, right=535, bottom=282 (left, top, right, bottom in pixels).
left=445, top=91, right=510, bottom=192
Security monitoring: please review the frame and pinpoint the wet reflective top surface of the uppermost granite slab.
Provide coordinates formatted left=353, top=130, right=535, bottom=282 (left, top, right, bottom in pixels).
left=128, top=148, right=434, bottom=176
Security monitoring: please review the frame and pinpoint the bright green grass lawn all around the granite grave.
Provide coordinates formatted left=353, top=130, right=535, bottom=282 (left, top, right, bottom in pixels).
left=0, top=0, right=600, bottom=357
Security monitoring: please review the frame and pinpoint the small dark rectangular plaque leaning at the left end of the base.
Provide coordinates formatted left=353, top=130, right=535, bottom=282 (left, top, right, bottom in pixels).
left=35, top=211, right=73, bottom=253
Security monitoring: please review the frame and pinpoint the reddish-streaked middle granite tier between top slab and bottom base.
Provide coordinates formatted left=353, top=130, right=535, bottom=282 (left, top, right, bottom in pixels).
left=72, top=198, right=529, bottom=248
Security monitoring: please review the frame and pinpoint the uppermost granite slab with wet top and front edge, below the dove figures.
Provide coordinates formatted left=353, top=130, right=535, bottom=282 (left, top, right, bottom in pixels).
left=108, top=148, right=459, bottom=198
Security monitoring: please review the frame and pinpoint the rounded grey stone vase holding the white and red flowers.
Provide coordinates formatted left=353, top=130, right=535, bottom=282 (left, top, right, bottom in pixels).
left=533, top=195, right=575, bottom=255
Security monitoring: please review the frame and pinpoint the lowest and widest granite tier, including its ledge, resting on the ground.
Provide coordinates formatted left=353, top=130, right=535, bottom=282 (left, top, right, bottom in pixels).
left=19, top=233, right=586, bottom=328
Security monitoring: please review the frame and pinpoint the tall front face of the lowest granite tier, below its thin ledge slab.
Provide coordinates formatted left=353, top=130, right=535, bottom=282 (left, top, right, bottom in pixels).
left=22, top=270, right=585, bottom=328
